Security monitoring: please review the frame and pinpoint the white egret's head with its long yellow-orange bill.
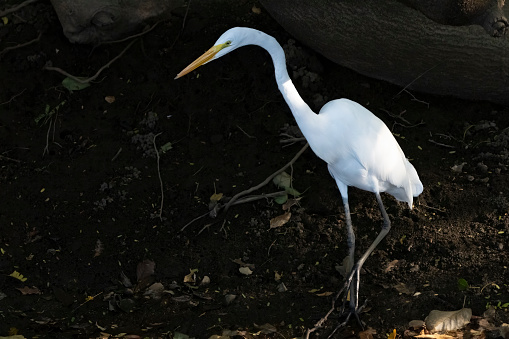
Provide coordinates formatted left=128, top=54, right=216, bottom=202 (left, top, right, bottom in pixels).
left=175, top=27, right=251, bottom=79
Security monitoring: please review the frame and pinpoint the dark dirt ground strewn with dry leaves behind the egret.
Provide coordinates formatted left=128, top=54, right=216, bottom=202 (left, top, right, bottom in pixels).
left=0, top=1, right=509, bottom=338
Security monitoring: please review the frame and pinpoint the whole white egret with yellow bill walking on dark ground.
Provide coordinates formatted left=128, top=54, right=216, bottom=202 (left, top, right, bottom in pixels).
left=175, top=27, right=423, bottom=330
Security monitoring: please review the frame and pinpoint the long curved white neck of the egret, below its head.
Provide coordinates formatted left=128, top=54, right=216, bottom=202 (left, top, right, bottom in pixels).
left=250, top=32, right=318, bottom=133
